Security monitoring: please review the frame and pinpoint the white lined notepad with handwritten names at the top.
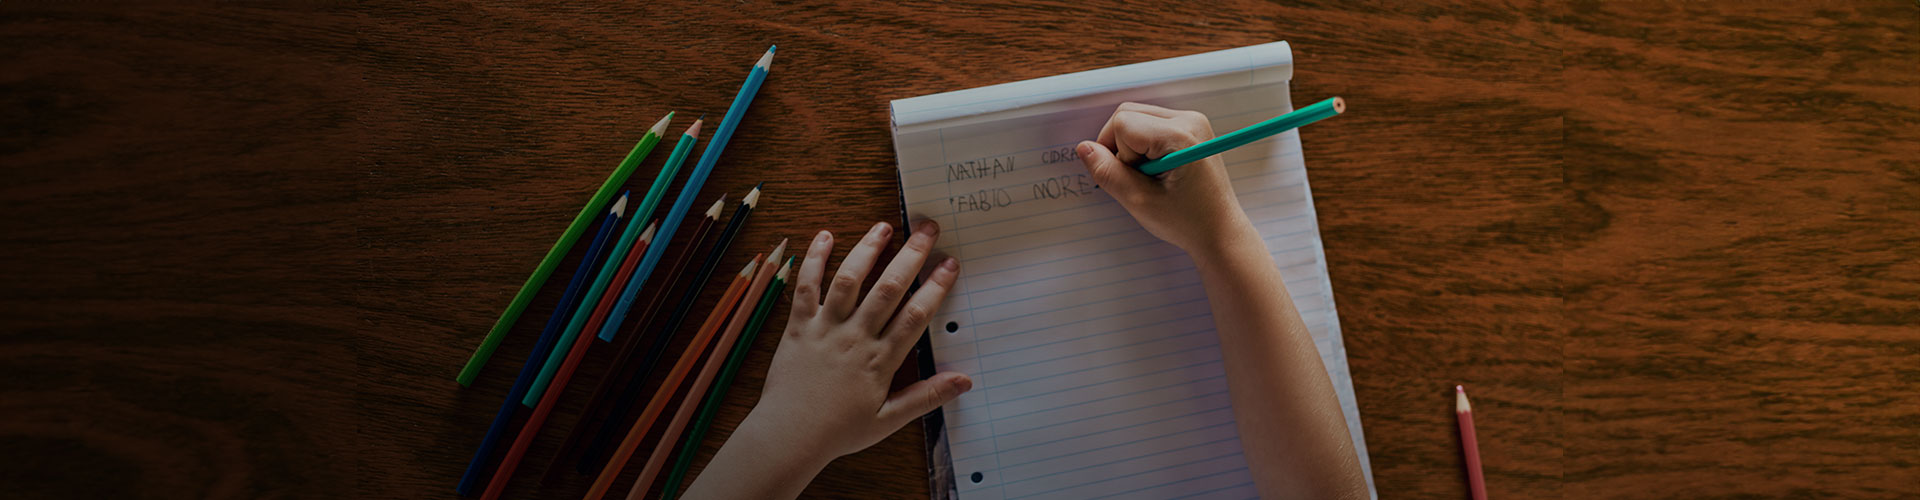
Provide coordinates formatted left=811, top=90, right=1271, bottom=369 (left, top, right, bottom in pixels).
left=893, top=42, right=1373, bottom=500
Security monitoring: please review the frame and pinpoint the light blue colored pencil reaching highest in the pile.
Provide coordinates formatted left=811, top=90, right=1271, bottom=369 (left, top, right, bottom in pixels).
left=599, top=46, right=778, bottom=342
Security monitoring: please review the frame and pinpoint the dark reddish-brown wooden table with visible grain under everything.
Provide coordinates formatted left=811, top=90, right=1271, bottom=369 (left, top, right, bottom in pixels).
left=0, top=2, right=1920, bottom=498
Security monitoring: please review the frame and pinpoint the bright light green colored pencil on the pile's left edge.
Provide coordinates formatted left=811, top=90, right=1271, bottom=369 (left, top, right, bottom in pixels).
left=455, top=112, right=674, bottom=387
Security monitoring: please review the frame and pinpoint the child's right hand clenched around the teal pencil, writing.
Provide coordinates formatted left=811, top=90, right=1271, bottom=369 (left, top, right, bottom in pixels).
left=1079, top=102, right=1260, bottom=254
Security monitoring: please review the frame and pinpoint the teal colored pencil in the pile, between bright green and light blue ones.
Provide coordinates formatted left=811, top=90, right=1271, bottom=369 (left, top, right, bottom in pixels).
left=520, top=119, right=705, bottom=408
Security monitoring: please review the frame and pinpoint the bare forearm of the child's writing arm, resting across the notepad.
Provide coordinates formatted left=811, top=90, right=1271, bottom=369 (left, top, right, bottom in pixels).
left=1192, top=225, right=1367, bottom=498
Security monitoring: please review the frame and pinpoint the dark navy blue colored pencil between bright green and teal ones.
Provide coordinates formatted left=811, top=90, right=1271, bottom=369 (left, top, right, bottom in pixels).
left=453, top=207, right=620, bottom=496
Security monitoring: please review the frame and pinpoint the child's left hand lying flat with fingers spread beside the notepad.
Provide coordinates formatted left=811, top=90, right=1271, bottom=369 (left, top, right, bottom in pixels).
left=741, top=221, right=973, bottom=465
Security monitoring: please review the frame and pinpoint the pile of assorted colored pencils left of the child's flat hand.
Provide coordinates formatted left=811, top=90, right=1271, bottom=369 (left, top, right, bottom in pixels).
left=457, top=48, right=791, bottom=500
